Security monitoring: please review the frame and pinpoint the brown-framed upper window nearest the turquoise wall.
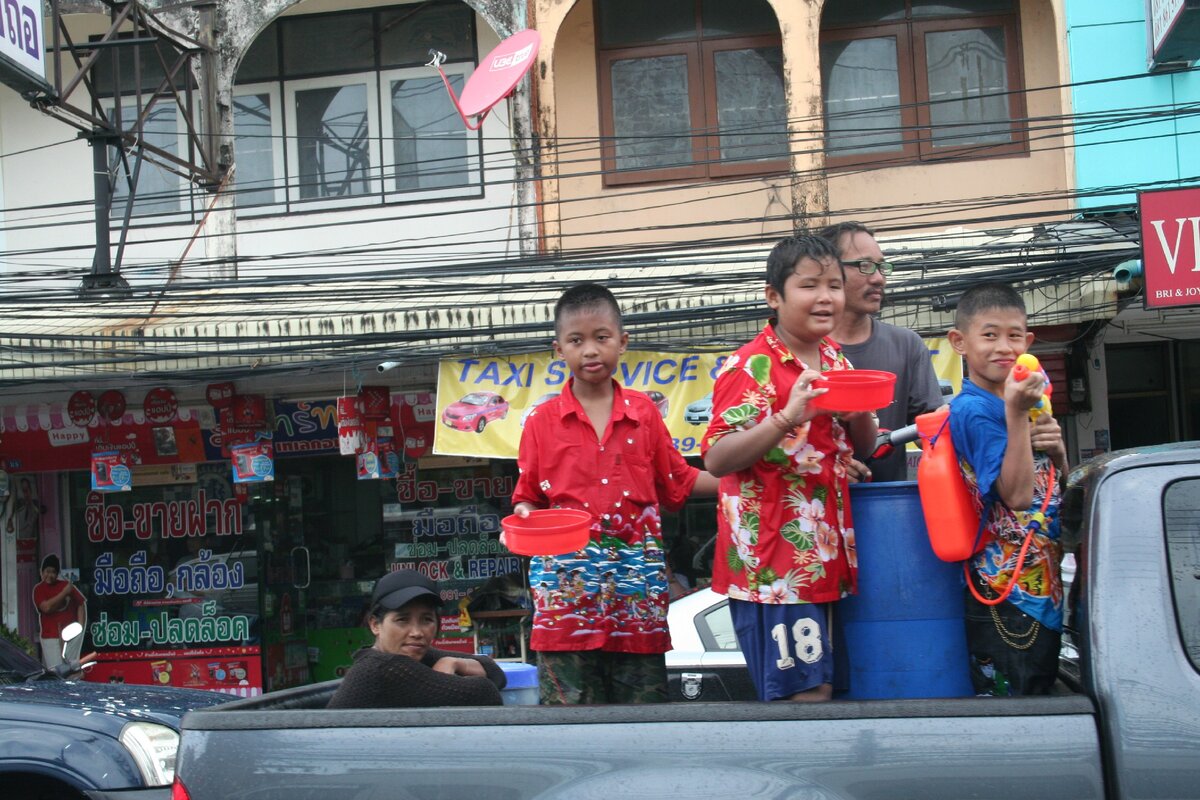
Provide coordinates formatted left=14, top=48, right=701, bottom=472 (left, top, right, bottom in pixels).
left=821, top=0, right=1026, bottom=166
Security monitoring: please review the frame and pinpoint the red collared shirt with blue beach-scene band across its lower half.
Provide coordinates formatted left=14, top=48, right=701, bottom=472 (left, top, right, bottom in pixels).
left=512, top=378, right=700, bottom=654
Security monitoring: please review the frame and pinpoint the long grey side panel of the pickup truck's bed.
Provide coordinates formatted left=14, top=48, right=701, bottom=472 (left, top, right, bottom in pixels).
left=178, top=696, right=1104, bottom=800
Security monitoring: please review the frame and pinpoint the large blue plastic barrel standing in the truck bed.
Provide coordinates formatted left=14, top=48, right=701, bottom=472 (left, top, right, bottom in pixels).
left=834, top=481, right=974, bottom=699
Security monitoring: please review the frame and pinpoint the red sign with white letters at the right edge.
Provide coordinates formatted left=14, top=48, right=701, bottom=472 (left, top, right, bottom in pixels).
left=1138, top=187, right=1200, bottom=308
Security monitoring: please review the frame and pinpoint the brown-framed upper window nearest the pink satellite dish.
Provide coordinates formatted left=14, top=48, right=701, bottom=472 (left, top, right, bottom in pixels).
left=596, top=0, right=788, bottom=185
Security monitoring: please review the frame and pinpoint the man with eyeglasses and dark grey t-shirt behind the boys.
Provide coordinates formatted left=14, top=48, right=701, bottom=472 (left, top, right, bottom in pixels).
left=821, top=222, right=942, bottom=482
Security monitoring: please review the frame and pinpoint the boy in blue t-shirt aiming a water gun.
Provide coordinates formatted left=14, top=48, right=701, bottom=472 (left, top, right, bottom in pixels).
left=948, top=283, right=1067, bottom=694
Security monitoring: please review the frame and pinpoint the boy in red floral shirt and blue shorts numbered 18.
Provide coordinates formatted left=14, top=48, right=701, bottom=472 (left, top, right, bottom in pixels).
left=702, top=236, right=877, bottom=700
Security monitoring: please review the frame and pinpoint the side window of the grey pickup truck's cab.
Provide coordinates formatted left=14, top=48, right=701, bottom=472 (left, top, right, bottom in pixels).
left=1163, top=479, right=1200, bottom=669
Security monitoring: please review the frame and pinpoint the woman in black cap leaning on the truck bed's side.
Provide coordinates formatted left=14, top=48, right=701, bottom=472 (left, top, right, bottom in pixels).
left=328, top=570, right=505, bottom=709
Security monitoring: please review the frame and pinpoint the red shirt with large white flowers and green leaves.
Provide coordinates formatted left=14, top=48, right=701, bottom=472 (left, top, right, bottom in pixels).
left=702, top=324, right=858, bottom=603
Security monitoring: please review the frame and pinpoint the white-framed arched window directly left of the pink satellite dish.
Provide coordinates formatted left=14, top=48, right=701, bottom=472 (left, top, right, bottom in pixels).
left=234, top=1, right=482, bottom=212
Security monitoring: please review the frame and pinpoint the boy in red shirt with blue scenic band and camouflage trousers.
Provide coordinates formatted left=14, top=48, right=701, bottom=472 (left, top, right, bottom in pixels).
left=512, top=283, right=716, bottom=704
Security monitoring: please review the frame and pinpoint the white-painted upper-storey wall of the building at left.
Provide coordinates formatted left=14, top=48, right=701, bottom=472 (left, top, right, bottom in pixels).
left=0, top=8, right=518, bottom=284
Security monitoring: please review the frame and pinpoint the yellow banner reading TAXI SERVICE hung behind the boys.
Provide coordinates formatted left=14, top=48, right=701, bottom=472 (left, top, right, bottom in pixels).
left=433, top=339, right=962, bottom=458
